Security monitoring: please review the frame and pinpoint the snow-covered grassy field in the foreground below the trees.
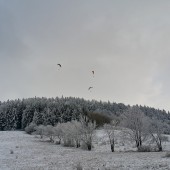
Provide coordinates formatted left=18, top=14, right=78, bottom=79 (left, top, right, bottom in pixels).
left=0, top=130, right=170, bottom=170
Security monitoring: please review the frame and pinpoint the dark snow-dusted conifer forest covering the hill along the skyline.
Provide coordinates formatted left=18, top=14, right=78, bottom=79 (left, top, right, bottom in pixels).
left=0, top=97, right=170, bottom=130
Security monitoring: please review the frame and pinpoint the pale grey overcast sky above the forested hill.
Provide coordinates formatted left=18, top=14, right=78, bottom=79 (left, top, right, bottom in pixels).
left=0, top=0, right=170, bottom=111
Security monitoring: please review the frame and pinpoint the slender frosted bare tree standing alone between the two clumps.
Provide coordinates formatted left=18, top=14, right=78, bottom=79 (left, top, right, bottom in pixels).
left=103, top=121, right=118, bottom=152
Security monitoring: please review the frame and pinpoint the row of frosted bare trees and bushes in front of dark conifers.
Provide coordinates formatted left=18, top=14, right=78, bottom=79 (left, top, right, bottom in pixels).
left=25, top=106, right=170, bottom=152
